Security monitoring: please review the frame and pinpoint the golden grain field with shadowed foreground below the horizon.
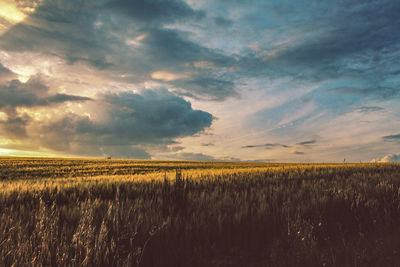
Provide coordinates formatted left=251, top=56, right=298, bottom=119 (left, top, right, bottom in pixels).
left=0, top=158, right=400, bottom=266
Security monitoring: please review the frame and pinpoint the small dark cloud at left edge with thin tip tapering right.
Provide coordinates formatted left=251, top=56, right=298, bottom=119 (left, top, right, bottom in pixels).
left=0, top=77, right=91, bottom=109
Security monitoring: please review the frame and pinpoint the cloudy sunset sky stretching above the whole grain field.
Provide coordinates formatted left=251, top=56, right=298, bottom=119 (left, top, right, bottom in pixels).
left=0, top=0, right=400, bottom=162
